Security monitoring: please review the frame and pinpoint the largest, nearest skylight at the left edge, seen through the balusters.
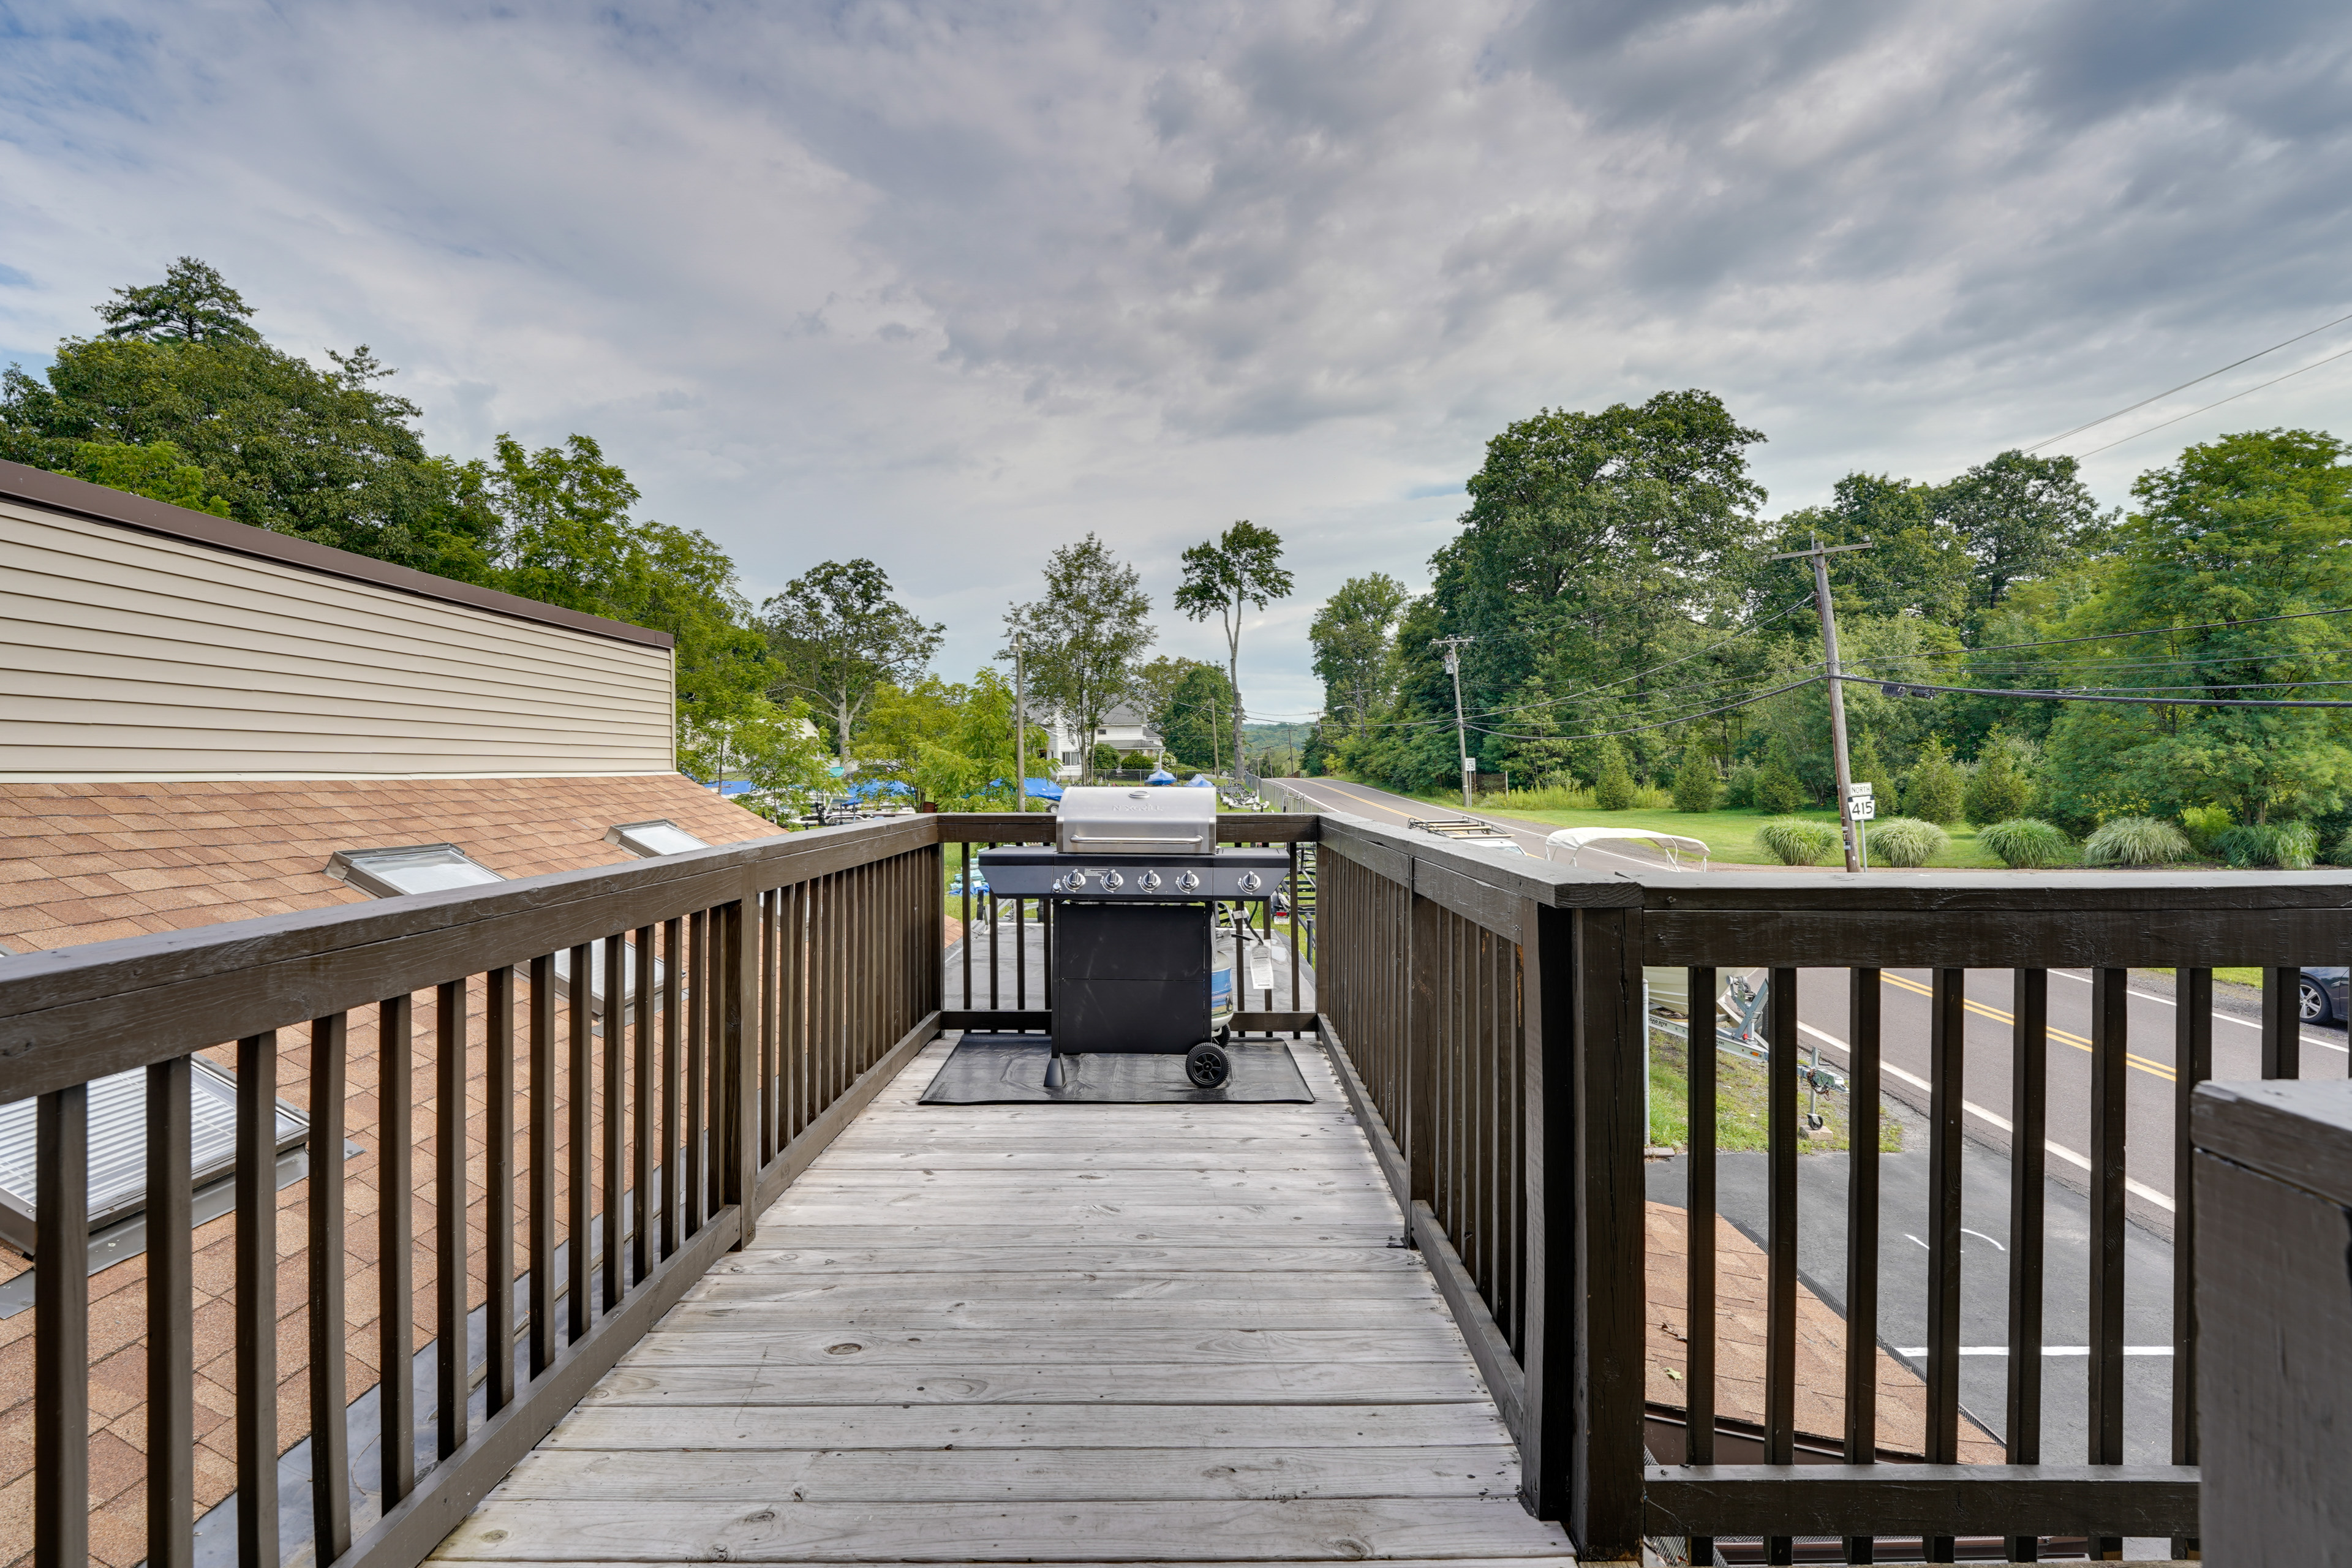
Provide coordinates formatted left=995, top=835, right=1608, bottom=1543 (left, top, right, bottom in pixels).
left=0, top=1055, right=311, bottom=1253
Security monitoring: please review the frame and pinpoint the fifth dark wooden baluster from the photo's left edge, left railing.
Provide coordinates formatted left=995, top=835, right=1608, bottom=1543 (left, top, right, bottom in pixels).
left=376, top=995, right=417, bottom=1507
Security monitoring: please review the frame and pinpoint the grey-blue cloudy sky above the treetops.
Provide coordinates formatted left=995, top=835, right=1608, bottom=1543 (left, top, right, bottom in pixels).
left=0, top=0, right=2352, bottom=715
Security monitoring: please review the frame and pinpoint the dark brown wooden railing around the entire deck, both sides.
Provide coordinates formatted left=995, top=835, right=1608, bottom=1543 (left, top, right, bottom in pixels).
left=0, top=813, right=2352, bottom=1568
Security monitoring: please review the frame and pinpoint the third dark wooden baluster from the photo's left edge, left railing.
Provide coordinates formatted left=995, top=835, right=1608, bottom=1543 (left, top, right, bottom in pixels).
left=235, top=1030, right=277, bottom=1563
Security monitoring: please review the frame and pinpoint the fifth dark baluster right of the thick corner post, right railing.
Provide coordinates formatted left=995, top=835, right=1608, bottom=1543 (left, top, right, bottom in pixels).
left=2004, top=968, right=2051, bottom=1563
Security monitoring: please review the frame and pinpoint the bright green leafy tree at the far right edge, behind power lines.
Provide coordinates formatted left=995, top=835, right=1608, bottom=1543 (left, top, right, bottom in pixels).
left=2044, top=430, right=2352, bottom=827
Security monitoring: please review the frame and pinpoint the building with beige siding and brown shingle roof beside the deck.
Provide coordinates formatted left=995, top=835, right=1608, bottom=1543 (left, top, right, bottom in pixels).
left=0, top=463, right=776, bottom=1561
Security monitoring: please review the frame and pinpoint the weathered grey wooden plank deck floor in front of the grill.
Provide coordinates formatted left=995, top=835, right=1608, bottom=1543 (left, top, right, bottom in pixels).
left=435, top=1041, right=1569, bottom=1568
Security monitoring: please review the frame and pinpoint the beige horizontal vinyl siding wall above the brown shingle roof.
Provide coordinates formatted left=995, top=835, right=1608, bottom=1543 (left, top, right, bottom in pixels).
left=0, top=501, right=675, bottom=783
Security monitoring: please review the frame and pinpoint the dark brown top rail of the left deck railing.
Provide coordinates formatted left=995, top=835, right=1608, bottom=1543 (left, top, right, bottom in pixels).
left=0, top=816, right=938, bottom=1102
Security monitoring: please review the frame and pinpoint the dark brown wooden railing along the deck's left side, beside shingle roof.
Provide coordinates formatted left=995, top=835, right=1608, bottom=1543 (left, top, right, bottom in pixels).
left=0, top=818, right=943, bottom=1568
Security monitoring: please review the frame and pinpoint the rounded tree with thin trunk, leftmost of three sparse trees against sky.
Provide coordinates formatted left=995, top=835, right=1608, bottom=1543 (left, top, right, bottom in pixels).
left=760, top=557, right=946, bottom=774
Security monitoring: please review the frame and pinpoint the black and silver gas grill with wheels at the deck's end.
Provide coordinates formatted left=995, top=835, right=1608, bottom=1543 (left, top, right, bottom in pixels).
left=981, top=785, right=1291, bottom=1088
